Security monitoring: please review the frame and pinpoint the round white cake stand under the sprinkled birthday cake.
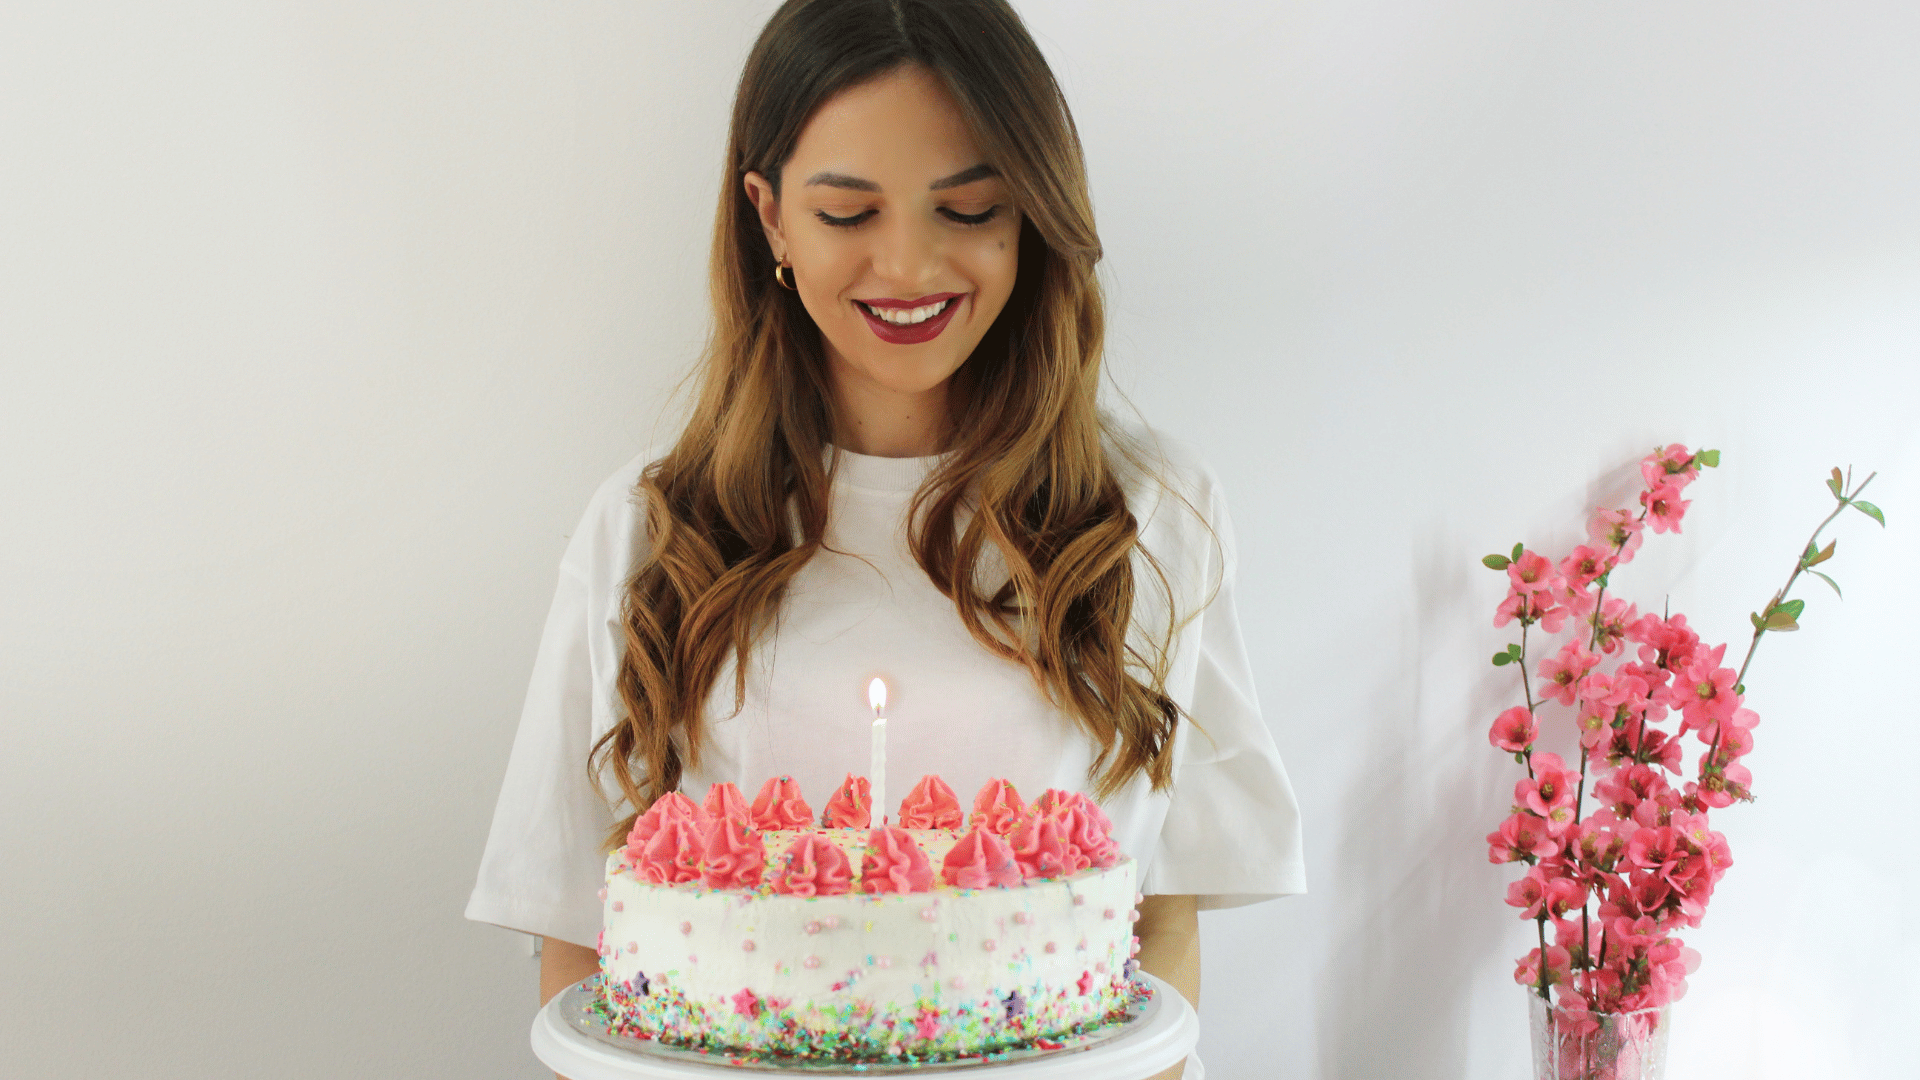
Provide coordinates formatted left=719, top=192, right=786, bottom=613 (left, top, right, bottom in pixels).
left=534, top=970, right=1200, bottom=1080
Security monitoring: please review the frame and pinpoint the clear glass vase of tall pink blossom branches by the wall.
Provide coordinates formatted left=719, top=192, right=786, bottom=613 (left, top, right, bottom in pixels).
left=1482, top=444, right=1885, bottom=1080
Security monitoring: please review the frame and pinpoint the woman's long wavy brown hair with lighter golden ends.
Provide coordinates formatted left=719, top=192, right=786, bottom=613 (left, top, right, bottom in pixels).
left=589, top=0, right=1181, bottom=849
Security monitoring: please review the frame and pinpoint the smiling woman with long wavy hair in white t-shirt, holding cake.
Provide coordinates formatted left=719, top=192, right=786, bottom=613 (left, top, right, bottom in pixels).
left=467, top=0, right=1304, bottom=1076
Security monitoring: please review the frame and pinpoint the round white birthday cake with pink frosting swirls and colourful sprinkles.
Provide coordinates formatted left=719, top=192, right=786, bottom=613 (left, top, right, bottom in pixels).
left=595, top=776, right=1142, bottom=1063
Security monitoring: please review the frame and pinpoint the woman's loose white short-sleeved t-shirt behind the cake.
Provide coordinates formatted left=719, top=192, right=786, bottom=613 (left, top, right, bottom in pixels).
left=467, top=420, right=1306, bottom=945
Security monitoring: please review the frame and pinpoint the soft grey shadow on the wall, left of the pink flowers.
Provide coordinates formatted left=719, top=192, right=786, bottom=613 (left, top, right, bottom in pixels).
left=1315, top=523, right=1511, bottom=1080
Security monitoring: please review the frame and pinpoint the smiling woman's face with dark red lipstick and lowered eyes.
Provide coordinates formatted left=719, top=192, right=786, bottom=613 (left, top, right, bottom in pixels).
left=747, top=65, right=1020, bottom=420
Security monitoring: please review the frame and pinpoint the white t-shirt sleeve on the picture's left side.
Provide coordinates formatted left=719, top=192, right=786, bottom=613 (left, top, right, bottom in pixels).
left=467, top=495, right=614, bottom=947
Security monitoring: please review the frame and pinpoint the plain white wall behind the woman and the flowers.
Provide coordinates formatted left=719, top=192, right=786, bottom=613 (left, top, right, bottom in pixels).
left=0, top=0, right=1920, bottom=1080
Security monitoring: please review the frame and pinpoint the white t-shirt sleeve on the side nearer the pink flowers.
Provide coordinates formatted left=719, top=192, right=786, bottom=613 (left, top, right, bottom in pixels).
left=1140, top=465, right=1308, bottom=911
